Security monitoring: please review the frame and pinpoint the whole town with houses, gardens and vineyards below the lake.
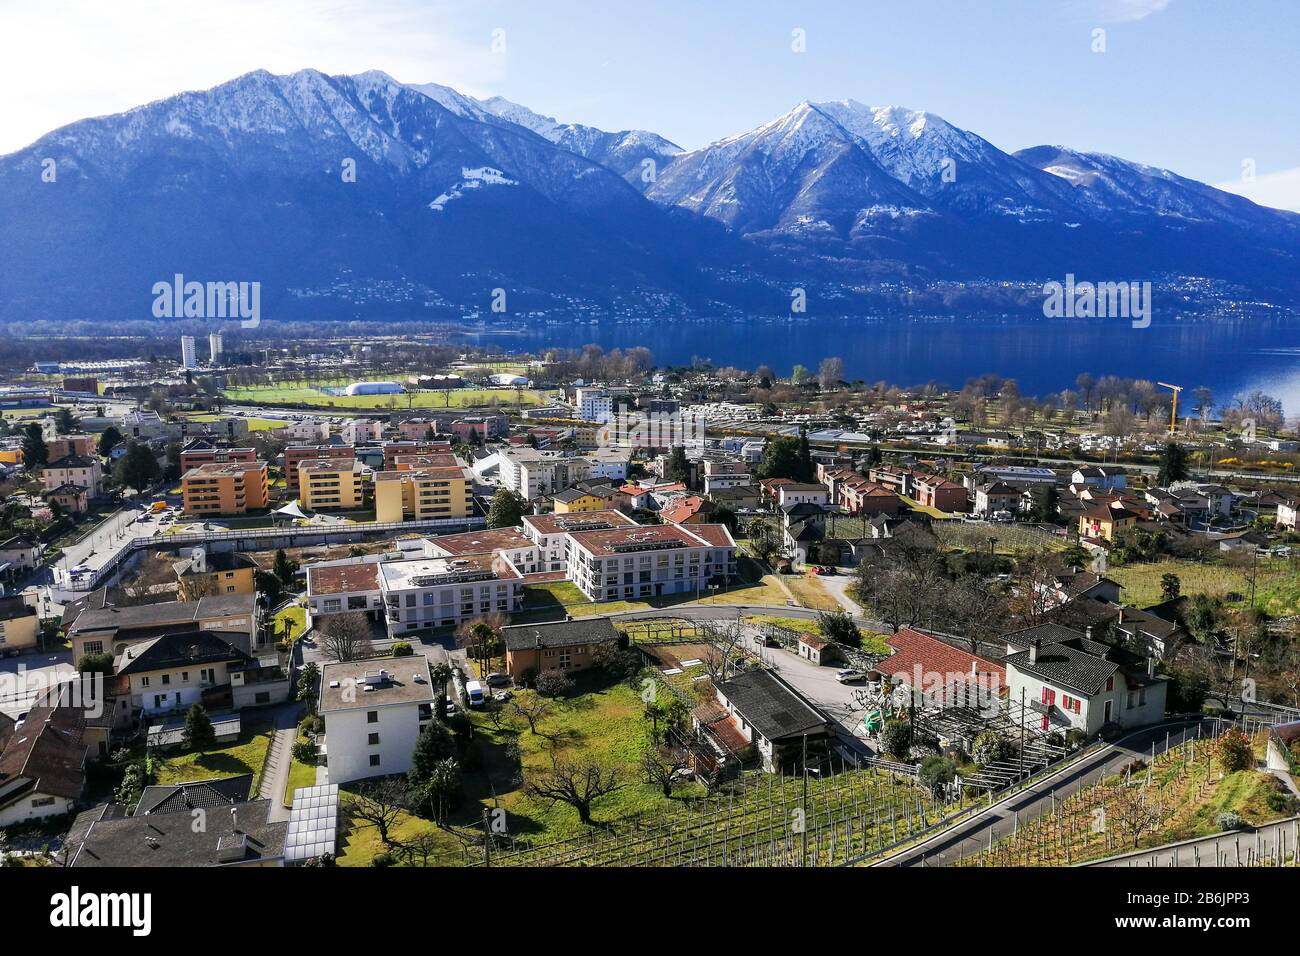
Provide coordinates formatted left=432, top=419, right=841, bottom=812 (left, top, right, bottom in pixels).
left=0, top=329, right=1300, bottom=868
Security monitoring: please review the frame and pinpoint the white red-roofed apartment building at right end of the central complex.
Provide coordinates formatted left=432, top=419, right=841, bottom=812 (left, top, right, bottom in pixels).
left=566, top=515, right=736, bottom=601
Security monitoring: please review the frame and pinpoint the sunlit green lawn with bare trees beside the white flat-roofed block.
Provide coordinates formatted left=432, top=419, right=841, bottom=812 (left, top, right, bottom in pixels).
left=338, top=674, right=702, bottom=866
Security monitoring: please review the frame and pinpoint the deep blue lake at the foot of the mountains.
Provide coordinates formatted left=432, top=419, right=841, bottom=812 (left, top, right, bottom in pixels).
left=460, top=319, right=1300, bottom=416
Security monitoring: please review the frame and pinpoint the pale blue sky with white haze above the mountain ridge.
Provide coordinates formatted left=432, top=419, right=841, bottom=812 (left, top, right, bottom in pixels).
left=0, top=0, right=1300, bottom=209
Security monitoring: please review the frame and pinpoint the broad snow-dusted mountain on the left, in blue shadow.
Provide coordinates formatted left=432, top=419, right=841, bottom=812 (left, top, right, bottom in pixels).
left=0, top=70, right=750, bottom=317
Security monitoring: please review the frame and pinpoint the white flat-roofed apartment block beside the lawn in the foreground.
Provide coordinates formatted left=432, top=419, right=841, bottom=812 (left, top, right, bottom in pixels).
left=319, top=654, right=436, bottom=783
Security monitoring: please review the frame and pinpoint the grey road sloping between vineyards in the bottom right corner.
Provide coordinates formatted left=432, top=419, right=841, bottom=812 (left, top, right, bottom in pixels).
left=876, top=719, right=1212, bottom=866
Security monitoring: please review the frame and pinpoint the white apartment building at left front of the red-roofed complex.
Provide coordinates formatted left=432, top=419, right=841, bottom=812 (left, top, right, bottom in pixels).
left=380, top=554, right=524, bottom=637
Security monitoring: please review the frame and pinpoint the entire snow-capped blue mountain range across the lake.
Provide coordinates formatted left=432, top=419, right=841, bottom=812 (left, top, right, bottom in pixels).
left=0, top=70, right=1300, bottom=320
